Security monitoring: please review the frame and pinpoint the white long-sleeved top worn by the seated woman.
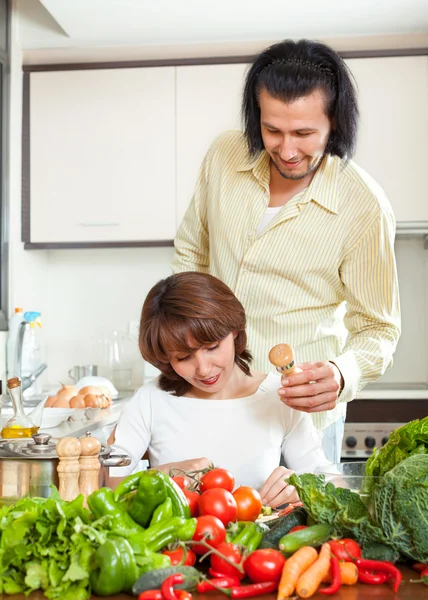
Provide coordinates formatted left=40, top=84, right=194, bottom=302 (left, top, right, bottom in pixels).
left=110, top=373, right=328, bottom=489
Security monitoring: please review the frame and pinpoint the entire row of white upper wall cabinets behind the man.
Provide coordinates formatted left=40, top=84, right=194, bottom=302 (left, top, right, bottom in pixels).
left=24, top=56, right=428, bottom=245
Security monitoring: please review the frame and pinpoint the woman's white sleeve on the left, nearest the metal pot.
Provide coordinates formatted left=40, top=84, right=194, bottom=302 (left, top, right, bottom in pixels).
left=109, top=386, right=152, bottom=477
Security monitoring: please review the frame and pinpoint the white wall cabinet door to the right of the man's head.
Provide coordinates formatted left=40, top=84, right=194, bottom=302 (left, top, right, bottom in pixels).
left=346, top=56, right=428, bottom=231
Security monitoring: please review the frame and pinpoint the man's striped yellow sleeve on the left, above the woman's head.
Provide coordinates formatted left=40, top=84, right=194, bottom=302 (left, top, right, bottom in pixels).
left=172, top=146, right=213, bottom=273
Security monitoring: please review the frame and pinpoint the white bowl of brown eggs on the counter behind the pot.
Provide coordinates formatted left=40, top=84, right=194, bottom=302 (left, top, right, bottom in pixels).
left=45, top=385, right=112, bottom=421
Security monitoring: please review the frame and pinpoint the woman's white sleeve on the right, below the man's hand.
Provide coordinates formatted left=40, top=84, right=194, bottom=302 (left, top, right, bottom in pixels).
left=282, top=407, right=331, bottom=474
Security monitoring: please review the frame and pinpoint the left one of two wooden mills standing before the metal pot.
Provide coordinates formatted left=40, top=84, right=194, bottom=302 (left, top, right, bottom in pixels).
left=56, top=437, right=81, bottom=500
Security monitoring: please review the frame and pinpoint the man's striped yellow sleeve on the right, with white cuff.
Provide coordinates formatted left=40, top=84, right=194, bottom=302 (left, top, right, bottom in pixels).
left=332, top=211, right=401, bottom=402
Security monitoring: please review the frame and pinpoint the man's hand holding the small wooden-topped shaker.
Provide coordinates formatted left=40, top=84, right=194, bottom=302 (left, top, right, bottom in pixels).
left=278, top=362, right=344, bottom=413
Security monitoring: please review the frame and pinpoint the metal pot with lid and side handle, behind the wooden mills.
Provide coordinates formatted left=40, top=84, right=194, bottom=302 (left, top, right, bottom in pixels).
left=0, top=433, right=131, bottom=498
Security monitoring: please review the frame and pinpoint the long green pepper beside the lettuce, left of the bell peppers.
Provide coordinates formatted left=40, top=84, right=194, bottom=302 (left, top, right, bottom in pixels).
left=87, top=487, right=143, bottom=537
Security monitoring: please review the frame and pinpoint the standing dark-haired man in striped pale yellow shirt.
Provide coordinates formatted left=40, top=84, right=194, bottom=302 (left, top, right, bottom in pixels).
left=173, top=40, right=400, bottom=462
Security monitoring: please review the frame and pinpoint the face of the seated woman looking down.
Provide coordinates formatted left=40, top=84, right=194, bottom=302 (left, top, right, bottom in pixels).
left=168, top=333, right=236, bottom=399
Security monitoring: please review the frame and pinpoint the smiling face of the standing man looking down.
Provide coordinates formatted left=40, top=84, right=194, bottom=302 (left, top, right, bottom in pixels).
left=259, top=89, right=331, bottom=179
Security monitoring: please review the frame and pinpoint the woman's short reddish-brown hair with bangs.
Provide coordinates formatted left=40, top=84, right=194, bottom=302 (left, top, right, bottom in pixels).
left=139, top=271, right=252, bottom=396
